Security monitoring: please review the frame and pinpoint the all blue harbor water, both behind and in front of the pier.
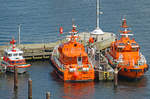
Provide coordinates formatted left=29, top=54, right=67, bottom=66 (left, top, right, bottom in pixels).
left=0, top=0, right=150, bottom=99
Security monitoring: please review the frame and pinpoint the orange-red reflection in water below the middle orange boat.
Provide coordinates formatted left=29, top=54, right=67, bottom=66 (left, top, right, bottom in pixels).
left=63, top=82, right=94, bottom=99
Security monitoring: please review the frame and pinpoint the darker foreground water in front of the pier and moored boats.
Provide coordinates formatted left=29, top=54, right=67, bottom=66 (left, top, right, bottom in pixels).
left=0, top=61, right=150, bottom=99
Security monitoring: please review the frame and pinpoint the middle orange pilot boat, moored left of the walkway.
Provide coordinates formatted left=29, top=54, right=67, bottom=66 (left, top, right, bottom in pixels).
left=51, top=25, right=94, bottom=81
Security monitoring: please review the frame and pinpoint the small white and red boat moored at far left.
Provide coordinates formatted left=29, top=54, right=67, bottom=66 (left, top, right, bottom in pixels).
left=1, top=39, right=31, bottom=73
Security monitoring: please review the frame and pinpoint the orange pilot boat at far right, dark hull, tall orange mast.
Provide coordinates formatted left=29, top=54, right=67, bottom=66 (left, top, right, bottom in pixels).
left=106, top=18, right=148, bottom=79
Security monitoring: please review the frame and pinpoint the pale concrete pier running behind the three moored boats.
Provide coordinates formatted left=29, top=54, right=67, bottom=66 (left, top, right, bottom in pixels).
left=0, top=32, right=115, bottom=59
